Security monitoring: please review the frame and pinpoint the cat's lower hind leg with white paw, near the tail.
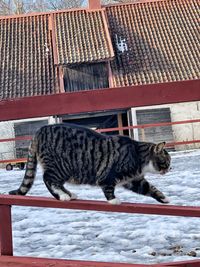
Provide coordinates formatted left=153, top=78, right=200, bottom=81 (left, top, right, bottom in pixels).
left=43, top=170, right=77, bottom=201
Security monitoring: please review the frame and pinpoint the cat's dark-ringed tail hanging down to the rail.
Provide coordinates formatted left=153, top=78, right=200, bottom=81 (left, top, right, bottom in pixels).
left=9, top=139, right=37, bottom=195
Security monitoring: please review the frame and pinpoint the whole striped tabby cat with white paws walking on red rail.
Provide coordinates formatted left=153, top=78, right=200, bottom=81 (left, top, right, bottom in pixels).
left=9, top=123, right=170, bottom=204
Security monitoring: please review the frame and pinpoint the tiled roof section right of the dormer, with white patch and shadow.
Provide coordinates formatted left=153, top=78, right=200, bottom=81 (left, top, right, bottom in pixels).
left=106, top=0, right=200, bottom=86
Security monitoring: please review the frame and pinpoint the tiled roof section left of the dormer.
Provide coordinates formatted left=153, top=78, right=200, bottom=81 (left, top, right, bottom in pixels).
left=0, top=15, right=58, bottom=99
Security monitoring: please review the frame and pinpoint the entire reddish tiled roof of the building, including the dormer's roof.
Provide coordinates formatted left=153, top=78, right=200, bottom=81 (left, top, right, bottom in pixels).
left=0, top=0, right=200, bottom=99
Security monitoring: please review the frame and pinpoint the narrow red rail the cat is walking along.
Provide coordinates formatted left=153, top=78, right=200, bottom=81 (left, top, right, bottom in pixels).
left=0, top=195, right=200, bottom=217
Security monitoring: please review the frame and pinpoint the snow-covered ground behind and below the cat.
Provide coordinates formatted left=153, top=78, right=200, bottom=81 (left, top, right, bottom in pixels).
left=0, top=150, right=200, bottom=263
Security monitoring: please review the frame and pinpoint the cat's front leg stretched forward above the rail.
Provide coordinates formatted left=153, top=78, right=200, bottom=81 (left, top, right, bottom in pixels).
left=124, top=177, right=169, bottom=204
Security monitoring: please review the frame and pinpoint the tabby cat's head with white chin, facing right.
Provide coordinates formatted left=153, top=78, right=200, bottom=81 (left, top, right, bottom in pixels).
left=145, top=142, right=171, bottom=174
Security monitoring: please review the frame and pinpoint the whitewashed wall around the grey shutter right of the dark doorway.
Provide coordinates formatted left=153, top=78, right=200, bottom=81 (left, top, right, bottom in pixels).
left=132, top=101, right=200, bottom=150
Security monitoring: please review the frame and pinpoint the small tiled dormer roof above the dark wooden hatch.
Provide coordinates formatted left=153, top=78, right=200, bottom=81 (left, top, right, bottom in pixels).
left=54, top=10, right=114, bottom=65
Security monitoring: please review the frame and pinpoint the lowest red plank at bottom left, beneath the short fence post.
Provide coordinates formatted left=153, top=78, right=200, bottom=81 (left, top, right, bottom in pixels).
left=0, top=256, right=149, bottom=267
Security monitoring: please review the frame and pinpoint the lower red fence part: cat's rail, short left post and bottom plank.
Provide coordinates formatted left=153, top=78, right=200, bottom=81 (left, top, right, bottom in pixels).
left=0, top=195, right=200, bottom=267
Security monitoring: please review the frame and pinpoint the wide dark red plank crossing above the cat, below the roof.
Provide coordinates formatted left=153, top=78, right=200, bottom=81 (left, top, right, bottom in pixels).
left=0, top=80, right=200, bottom=121
